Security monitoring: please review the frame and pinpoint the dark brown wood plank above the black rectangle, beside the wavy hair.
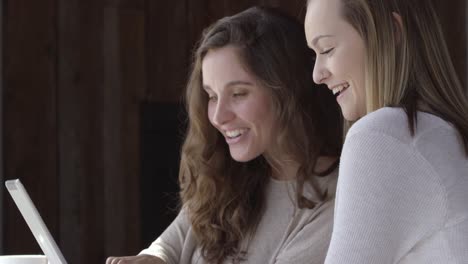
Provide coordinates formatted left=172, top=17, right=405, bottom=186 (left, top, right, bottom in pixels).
left=147, top=0, right=189, bottom=102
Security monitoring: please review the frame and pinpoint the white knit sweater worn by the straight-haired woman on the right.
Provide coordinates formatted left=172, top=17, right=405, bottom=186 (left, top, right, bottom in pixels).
left=325, top=108, right=468, bottom=264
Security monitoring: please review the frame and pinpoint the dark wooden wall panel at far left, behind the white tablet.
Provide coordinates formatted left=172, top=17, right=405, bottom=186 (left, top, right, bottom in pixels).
left=1, top=0, right=60, bottom=254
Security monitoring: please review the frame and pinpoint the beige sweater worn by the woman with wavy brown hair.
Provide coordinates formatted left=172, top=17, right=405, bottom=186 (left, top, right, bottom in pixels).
left=140, top=171, right=337, bottom=264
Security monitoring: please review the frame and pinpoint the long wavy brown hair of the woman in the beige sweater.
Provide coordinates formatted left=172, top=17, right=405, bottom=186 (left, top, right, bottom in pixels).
left=179, top=7, right=342, bottom=263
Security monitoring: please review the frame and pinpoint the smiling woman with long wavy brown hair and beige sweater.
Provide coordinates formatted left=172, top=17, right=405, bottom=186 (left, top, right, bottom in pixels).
left=108, top=5, right=342, bottom=264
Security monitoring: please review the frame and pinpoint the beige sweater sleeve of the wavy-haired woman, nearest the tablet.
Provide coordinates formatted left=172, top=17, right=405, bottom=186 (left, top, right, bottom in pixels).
left=140, top=209, right=190, bottom=264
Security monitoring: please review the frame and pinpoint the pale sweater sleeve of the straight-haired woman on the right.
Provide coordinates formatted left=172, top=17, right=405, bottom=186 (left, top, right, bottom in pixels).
left=325, top=130, right=446, bottom=264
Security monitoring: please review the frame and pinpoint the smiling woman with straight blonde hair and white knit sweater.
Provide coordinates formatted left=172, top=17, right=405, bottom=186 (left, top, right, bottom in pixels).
left=305, top=0, right=468, bottom=264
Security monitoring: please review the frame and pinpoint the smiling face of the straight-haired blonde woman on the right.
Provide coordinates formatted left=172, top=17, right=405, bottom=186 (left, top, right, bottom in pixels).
left=304, top=0, right=366, bottom=121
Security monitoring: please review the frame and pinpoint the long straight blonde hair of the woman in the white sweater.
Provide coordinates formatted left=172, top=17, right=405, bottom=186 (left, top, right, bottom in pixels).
left=341, top=0, right=468, bottom=155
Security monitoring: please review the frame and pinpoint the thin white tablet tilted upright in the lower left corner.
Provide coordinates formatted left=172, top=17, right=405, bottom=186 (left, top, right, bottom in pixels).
left=5, top=179, right=67, bottom=264
